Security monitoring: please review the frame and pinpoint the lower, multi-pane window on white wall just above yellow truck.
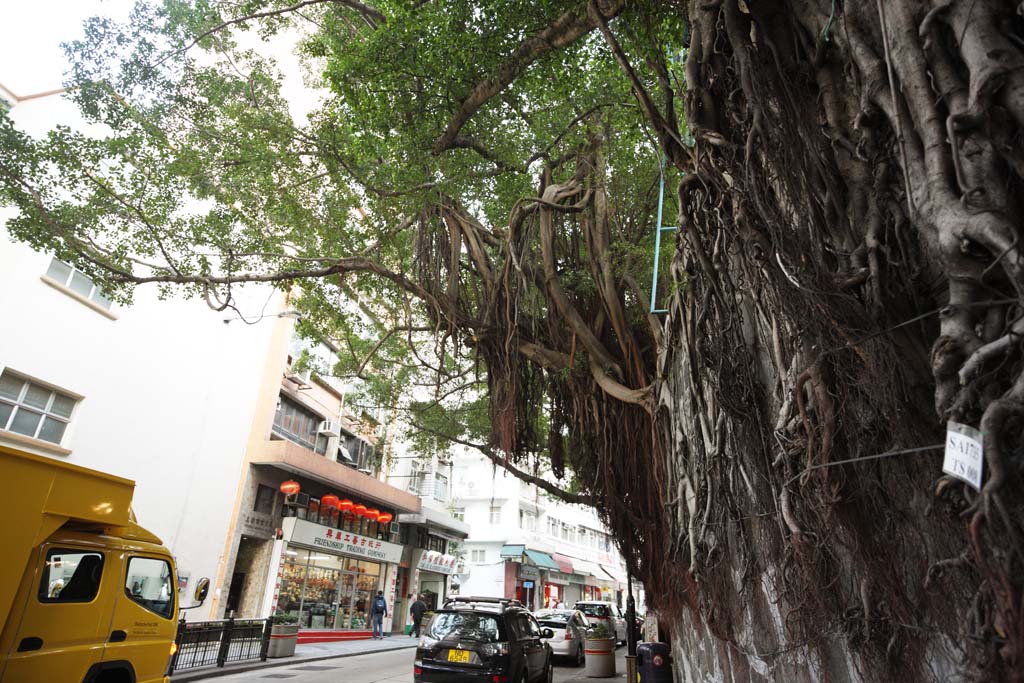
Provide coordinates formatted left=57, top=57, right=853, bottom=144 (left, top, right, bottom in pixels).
left=0, top=370, right=77, bottom=443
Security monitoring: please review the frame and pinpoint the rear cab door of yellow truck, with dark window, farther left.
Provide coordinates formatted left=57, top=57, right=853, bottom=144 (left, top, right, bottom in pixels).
left=3, top=544, right=120, bottom=683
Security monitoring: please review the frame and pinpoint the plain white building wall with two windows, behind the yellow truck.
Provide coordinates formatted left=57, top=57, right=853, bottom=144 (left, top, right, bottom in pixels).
left=0, top=88, right=282, bottom=618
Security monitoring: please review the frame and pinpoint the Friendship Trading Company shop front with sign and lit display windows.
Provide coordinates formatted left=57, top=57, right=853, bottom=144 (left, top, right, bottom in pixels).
left=272, top=517, right=402, bottom=642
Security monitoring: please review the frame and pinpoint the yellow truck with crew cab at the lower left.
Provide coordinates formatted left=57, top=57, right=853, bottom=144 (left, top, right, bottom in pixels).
left=0, top=445, right=209, bottom=683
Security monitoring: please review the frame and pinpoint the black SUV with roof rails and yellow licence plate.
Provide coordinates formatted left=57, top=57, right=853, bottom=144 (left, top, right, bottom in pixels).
left=413, top=597, right=554, bottom=683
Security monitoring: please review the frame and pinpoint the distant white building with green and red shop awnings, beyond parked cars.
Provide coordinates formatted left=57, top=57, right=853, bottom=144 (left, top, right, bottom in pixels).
left=452, top=451, right=642, bottom=609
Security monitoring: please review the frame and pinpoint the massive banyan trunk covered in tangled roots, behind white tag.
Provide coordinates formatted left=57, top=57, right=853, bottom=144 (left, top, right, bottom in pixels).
left=641, top=0, right=1024, bottom=682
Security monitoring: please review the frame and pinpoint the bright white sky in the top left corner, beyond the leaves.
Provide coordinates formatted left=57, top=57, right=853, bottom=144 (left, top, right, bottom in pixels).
left=0, top=0, right=134, bottom=97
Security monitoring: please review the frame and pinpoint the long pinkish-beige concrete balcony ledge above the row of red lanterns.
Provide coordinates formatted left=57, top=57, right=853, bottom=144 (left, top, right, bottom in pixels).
left=249, top=440, right=422, bottom=512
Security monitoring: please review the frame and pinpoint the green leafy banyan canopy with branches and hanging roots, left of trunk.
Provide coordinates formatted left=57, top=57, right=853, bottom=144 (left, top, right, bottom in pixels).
left=0, top=0, right=683, bottom=581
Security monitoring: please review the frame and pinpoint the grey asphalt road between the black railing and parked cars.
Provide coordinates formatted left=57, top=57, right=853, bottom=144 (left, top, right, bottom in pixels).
left=210, top=647, right=626, bottom=683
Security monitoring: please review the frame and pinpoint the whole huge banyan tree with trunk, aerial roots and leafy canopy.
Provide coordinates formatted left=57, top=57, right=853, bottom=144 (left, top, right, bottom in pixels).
left=0, top=0, right=1024, bottom=681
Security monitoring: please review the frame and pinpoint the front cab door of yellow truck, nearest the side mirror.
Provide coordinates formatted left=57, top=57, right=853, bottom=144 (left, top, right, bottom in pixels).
left=103, top=552, right=177, bottom=683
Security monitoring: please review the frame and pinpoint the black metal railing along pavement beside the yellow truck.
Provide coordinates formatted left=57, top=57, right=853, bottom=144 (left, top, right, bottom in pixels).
left=168, top=617, right=271, bottom=674
